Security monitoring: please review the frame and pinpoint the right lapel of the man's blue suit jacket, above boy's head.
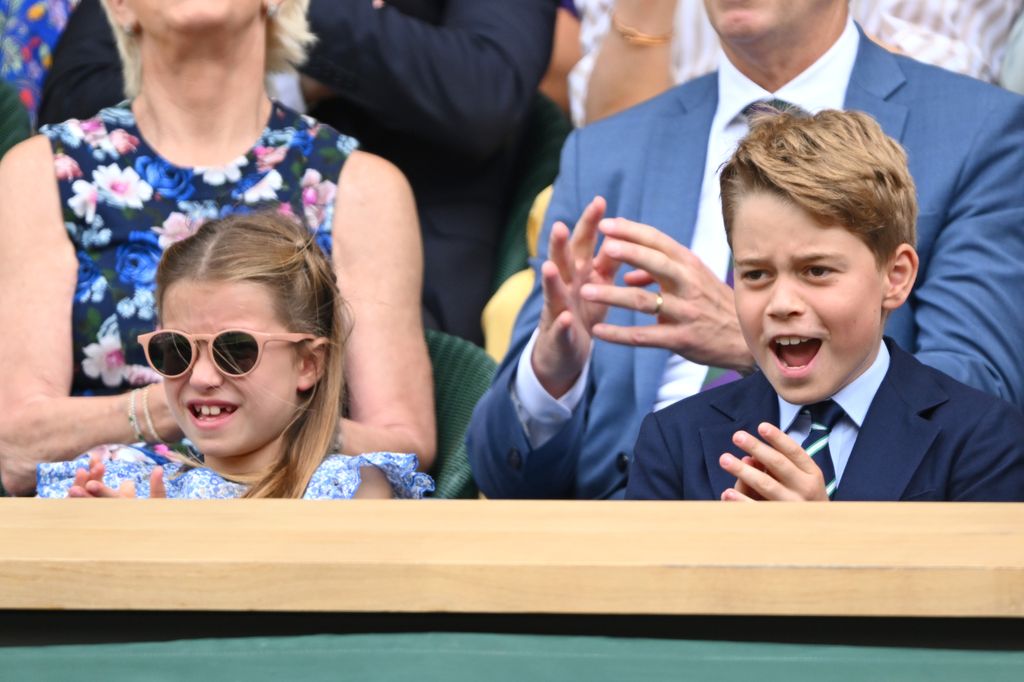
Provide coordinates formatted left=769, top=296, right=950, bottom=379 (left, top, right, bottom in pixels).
left=845, top=27, right=907, bottom=140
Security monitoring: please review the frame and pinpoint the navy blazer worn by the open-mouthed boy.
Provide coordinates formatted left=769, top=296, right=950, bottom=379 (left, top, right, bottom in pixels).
left=626, top=339, right=1024, bottom=502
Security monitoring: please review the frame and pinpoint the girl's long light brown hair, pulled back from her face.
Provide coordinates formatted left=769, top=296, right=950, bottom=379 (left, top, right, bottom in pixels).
left=157, top=212, right=348, bottom=498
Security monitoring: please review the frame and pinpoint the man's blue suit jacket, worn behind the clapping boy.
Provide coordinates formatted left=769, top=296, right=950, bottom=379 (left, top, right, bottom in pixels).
left=468, top=29, right=1024, bottom=499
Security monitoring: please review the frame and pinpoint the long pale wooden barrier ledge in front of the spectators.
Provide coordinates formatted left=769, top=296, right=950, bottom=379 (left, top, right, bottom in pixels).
left=0, top=499, right=1024, bottom=617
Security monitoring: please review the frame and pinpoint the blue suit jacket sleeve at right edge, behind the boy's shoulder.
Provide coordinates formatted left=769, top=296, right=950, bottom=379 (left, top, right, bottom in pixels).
left=910, top=89, right=1024, bottom=406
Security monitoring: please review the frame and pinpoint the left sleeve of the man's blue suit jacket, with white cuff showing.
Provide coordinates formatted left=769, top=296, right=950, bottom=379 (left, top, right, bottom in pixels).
left=467, top=133, right=593, bottom=498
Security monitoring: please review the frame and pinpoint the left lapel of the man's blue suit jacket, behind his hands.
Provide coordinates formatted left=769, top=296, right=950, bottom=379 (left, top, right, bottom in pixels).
left=624, top=74, right=718, bottom=404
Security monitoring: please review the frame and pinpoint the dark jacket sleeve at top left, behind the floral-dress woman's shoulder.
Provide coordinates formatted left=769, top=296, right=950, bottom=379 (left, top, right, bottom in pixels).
left=38, top=0, right=125, bottom=125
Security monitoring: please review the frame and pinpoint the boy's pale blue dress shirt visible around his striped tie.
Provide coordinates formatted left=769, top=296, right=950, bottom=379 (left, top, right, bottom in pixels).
left=778, top=342, right=889, bottom=485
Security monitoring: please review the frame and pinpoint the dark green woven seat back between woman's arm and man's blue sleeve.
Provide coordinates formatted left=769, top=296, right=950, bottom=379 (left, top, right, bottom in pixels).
left=427, top=330, right=497, bottom=499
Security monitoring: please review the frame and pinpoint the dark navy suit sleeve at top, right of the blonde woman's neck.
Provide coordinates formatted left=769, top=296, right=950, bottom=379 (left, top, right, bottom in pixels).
left=303, top=0, right=556, bottom=159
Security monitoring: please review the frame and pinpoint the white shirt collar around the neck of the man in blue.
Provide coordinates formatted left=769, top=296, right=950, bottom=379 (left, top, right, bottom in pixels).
left=715, top=18, right=860, bottom=128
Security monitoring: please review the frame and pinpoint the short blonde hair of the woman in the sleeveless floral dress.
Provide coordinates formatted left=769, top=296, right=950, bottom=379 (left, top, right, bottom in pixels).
left=100, top=0, right=316, bottom=98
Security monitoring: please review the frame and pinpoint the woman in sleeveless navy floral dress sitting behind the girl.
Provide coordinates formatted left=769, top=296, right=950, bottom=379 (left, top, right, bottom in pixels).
left=0, top=0, right=434, bottom=494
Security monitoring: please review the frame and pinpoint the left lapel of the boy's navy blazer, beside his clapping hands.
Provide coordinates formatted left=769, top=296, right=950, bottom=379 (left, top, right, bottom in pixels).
left=699, top=372, right=778, bottom=493
